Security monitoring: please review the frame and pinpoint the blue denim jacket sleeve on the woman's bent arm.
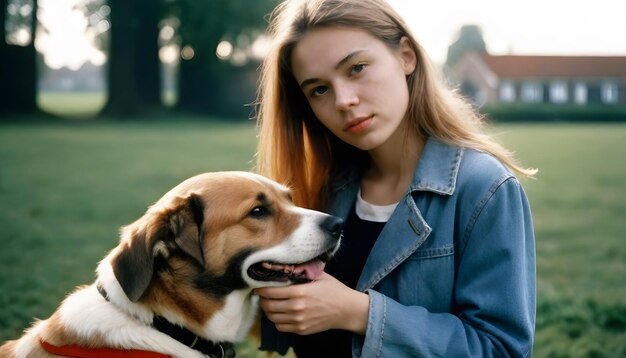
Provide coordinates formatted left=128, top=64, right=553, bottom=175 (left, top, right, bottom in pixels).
left=354, top=176, right=535, bottom=357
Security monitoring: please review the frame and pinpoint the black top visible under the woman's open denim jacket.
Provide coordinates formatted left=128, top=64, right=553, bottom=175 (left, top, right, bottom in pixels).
left=294, top=207, right=385, bottom=358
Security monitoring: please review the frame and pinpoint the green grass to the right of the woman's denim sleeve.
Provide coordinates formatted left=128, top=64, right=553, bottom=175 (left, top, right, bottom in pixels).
left=497, top=123, right=626, bottom=357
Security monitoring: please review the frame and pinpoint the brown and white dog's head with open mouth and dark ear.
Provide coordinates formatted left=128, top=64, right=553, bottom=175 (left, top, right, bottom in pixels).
left=101, top=172, right=342, bottom=302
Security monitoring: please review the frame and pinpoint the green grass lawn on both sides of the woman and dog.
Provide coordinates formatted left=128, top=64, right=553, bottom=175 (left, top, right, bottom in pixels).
left=0, top=118, right=626, bottom=357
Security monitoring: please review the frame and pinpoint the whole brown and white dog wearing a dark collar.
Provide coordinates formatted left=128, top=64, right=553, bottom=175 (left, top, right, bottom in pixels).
left=0, top=172, right=342, bottom=358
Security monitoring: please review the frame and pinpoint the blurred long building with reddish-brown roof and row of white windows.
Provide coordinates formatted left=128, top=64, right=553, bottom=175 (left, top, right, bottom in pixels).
left=449, top=51, right=626, bottom=107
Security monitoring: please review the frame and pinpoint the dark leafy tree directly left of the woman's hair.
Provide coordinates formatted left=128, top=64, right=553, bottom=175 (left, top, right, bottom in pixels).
left=172, top=0, right=277, bottom=117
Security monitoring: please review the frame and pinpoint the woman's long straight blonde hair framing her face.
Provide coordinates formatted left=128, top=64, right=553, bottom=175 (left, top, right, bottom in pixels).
left=256, top=0, right=536, bottom=210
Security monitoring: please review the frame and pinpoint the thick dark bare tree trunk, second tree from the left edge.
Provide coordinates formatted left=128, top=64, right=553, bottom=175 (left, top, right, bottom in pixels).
left=103, top=0, right=162, bottom=116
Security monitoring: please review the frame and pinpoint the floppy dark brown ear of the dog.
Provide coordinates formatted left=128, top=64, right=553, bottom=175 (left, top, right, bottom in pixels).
left=111, top=194, right=204, bottom=302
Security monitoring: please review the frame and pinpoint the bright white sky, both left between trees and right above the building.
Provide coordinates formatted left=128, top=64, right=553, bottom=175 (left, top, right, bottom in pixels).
left=31, top=0, right=626, bottom=69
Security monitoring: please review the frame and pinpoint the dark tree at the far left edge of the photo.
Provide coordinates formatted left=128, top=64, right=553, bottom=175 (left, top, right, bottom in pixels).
left=0, top=0, right=37, bottom=117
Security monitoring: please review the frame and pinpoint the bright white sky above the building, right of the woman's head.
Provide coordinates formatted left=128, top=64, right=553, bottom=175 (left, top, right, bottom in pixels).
left=388, top=0, right=626, bottom=63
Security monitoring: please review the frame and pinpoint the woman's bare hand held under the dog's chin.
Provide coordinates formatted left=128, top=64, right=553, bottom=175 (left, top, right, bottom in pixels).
left=255, top=273, right=369, bottom=335
